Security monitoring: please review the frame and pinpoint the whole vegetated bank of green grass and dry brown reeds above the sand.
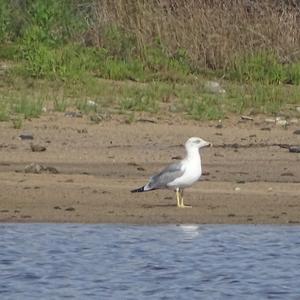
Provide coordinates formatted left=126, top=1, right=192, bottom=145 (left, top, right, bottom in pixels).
left=0, top=0, right=300, bottom=128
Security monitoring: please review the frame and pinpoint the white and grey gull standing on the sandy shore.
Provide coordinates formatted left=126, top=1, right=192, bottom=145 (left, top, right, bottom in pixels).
left=131, top=137, right=211, bottom=208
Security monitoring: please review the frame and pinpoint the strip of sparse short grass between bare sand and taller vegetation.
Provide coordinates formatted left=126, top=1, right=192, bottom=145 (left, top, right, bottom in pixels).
left=0, top=77, right=300, bottom=123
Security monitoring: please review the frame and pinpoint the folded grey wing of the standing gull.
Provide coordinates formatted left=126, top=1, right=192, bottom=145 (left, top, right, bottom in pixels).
left=147, top=162, right=185, bottom=190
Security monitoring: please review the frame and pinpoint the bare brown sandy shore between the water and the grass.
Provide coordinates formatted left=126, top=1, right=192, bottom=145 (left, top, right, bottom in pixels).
left=0, top=113, right=300, bottom=224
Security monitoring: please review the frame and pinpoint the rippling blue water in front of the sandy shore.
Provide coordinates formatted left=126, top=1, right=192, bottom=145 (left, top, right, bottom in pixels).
left=0, top=224, right=300, bottom=300
